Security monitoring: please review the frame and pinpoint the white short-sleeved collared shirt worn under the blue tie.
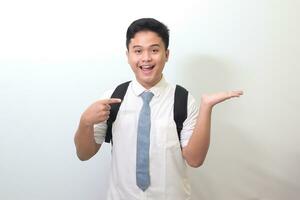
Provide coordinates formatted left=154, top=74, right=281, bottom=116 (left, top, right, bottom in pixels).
left=94, top=78, right=198, bottom=200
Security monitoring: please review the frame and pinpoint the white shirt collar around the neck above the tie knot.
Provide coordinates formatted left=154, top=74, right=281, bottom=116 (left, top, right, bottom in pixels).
left=131, top=77, right=167, bottom=97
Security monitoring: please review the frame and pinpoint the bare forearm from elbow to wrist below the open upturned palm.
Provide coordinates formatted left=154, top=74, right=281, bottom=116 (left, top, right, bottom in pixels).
left=183, top=102, right=212, bottom=167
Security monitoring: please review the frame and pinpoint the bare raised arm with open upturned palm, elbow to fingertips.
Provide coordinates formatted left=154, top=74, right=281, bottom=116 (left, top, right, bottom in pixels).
left=182, top=91, right=243, bottom=167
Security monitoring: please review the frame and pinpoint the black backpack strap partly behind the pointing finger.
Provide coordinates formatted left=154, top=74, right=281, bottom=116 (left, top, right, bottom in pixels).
left=105, top=81, right=130, bottom=143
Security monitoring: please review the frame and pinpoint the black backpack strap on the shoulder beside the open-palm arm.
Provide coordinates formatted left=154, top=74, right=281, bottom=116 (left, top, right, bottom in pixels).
left=174, top=85, right=188, bottom=146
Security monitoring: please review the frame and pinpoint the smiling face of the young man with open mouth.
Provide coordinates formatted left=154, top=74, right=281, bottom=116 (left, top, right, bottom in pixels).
left=127, top=31, right=169, bottom=89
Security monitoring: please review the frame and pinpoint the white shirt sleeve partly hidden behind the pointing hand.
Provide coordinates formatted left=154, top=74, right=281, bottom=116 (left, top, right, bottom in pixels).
left=94, top=90, right=113, bottom=144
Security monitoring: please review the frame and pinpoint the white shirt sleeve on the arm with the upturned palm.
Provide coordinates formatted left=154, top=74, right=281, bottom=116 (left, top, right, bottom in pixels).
left=180, top=93, right=199, bottom=147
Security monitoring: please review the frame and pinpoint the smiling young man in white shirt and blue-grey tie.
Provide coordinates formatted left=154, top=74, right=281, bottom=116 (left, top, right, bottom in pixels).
left=75, top=18, right=242, bottom=200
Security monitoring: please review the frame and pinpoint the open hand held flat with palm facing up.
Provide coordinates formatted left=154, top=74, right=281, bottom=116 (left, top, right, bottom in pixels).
left=201, top=91, right=243, bottom=107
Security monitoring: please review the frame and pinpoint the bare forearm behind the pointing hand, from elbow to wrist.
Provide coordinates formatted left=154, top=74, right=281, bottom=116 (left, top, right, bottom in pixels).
left=74, top=122, right=101, bottom=160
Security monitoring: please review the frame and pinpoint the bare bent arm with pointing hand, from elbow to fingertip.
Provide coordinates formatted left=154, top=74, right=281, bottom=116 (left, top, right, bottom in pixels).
left=74, top=99, right=121, bottom=161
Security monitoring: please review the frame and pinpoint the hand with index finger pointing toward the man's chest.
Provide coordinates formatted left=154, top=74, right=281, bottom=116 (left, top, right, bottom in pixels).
left=80, top=98, right=121, bottom=126
